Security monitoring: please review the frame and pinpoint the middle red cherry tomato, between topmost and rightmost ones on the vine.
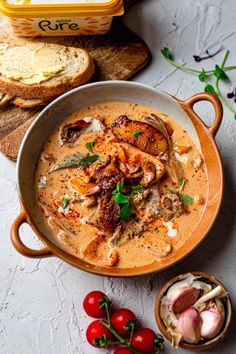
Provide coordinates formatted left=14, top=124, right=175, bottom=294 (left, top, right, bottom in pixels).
left=111, top=309, right=136, bottom=337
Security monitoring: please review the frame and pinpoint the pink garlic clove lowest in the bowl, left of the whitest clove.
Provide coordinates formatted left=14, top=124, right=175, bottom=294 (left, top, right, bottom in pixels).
left=177, top=307, right=202, bottom=343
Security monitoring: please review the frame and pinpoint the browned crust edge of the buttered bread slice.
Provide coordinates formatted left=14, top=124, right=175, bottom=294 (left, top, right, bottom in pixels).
left=0, top=44, right=94, bottom=101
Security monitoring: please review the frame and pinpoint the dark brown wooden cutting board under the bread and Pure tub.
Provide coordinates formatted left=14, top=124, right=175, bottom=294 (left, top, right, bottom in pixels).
left=0, top=0, right=151, bottom=160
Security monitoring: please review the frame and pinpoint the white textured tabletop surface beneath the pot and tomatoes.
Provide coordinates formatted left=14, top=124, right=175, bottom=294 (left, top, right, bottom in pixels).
left=0, top=0, right=236, bottom=354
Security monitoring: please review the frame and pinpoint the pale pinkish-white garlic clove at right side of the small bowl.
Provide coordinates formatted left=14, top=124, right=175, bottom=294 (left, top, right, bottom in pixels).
left=200, top=300, right=225, bottom=339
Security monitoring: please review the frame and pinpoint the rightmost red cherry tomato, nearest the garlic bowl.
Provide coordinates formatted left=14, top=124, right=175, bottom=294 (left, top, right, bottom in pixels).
left=132, top=328, right=156, bottom=354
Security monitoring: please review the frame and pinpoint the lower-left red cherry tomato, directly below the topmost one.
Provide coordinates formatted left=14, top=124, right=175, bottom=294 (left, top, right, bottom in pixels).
left=86, top=320, right=114, bottom=347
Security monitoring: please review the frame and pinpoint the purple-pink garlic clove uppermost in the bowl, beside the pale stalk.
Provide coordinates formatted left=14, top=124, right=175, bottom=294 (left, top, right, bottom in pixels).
left=167, top=286, right=201, bottom=313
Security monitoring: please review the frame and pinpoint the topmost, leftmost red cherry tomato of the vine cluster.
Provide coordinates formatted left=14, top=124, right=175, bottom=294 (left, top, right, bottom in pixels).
left=83, top=291, right=106, bottom=318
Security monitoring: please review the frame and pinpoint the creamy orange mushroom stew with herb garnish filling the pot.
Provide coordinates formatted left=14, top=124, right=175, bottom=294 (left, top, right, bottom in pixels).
left=35, top=101, right=208, bottom=268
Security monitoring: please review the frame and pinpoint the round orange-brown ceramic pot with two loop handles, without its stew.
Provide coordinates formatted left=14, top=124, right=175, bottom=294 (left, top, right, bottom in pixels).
left=11, top=81, right=223, bottom=277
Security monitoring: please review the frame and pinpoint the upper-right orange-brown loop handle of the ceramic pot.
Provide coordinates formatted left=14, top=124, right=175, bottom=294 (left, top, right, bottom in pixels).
left=181, top=92, right=223, bottom=136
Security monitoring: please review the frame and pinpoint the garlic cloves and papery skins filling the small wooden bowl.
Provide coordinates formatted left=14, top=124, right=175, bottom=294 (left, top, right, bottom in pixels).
left=160, top=273, right=228, bottom=348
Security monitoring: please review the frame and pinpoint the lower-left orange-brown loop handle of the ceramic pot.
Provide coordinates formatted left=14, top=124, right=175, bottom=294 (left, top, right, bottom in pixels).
left=11, top=209, right=53, bottom=258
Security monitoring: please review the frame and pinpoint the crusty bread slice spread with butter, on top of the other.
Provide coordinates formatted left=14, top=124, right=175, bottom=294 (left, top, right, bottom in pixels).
left=0, top=42, right=94, bottom=101
